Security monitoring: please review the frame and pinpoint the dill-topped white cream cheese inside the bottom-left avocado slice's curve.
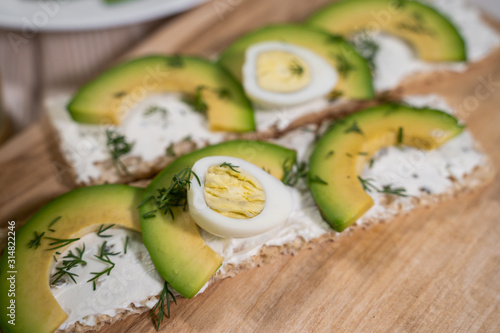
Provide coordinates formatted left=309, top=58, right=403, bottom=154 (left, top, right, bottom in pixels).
left=51, top=228, right=164, bottom=329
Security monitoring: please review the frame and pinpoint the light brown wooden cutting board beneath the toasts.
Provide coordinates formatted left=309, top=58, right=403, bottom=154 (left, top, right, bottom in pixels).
left=0, top=0, right=500, bottom=333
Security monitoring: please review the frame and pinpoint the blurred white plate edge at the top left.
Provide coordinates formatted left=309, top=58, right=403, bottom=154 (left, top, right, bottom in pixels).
left=0, top=0, right=204, bottom=34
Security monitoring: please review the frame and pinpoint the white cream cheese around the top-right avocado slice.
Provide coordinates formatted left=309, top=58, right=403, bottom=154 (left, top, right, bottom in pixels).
left=374, top=0, right=500, bottom=91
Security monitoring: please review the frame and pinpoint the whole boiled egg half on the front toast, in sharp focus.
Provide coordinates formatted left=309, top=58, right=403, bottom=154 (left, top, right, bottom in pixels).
left=188, top=156, right=292, bottom=238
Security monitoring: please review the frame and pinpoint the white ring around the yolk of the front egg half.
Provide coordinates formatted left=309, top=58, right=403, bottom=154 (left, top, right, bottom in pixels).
left=187, top=156, right=293, bottom=238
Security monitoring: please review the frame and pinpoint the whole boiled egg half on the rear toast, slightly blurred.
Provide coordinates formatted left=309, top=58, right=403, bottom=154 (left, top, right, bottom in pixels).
left=242, top=42, right=338, bottom=107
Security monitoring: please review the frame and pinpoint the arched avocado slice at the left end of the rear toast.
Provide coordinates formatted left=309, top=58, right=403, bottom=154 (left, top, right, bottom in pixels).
left=67, top=55, right=255, bottom=132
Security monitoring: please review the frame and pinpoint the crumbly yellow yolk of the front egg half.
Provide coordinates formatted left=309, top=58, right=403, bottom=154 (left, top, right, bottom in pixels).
left=204, top=165, right=266, bottom=219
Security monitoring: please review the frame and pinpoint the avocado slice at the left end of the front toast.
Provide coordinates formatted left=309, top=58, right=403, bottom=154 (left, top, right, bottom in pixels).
left=0, top=185, right=143, bottom=333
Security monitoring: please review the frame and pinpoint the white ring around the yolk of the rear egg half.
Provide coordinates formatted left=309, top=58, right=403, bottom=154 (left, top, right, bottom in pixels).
left=242, top=41, right=339, bottom=108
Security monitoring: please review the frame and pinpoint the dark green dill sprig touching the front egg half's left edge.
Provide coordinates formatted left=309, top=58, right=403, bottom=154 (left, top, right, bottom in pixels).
left=139, top=167, right=201, bottom=219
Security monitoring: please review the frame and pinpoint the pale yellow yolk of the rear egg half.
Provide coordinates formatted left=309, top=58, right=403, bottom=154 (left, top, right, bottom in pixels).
left=256, top=51, right=311, bottom=93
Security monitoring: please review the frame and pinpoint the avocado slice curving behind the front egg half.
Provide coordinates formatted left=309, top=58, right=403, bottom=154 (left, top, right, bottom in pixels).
left=139, top=140, right=296, bottom=298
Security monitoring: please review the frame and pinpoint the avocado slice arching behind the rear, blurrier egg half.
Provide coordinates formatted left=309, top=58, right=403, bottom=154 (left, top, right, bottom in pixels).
left=218, top=24, right=374, bottom=99
